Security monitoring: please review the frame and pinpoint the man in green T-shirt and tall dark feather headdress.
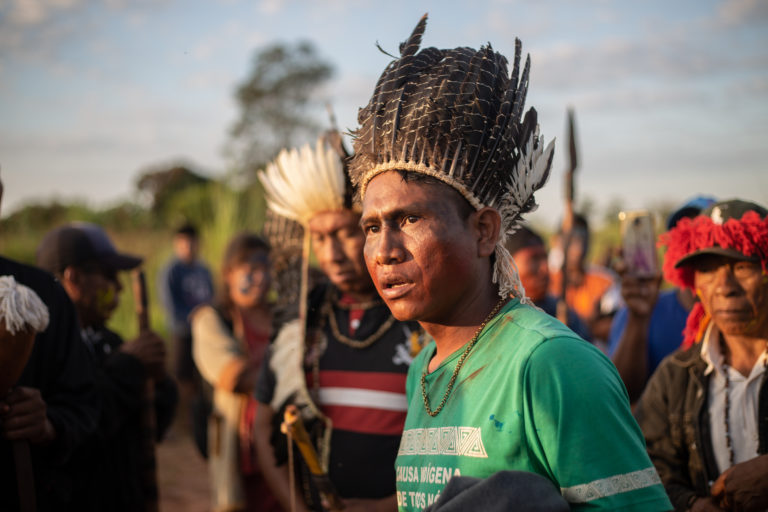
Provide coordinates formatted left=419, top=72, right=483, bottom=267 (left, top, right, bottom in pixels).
left=350, top=17, right=671, bottom=511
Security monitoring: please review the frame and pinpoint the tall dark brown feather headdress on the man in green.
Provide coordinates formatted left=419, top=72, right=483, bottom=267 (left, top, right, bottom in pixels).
left=350, top=15, right=554, bottom=300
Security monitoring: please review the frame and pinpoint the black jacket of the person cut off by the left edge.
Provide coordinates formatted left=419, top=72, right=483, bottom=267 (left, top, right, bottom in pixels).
left=0, top=257, right=101, bottom=511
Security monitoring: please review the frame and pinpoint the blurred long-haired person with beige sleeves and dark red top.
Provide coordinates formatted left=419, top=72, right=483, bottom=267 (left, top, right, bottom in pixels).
left=191, top=233, right=282, bottom=512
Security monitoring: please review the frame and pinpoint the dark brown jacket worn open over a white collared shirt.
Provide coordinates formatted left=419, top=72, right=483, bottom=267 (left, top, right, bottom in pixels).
left=635, top=344, right=768, bottom=510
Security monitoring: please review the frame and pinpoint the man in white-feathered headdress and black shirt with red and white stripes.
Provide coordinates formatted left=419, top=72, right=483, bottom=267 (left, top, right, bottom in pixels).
left=256, top=132, right=418, bottom=512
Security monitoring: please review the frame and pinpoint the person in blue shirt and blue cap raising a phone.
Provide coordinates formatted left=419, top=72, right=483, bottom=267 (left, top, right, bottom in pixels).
left=608, top=196, right=715, bottom=402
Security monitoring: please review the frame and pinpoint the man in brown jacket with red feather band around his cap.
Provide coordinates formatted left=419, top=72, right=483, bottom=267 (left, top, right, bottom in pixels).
left=636, top=199, right=768, bottom=511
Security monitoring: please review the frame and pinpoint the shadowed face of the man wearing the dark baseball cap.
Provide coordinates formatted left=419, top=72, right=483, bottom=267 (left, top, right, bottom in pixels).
left=66, top=265, right=123, bottom=327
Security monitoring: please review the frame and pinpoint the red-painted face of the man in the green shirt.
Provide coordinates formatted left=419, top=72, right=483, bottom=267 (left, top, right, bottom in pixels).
left=361, top=171, right=485, bottom=325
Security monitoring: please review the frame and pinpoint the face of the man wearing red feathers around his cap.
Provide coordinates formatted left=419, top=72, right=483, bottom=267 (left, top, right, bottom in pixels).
left=694, top=255, right=768, bottom=337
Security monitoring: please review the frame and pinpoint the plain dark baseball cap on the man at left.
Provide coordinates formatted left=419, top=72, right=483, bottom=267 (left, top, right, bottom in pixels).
left=37, top=222, right=142, bottom=274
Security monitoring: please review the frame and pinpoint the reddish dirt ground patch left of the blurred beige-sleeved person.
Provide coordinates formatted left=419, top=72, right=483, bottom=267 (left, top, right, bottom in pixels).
left=156, top=416, right=211, bottom=512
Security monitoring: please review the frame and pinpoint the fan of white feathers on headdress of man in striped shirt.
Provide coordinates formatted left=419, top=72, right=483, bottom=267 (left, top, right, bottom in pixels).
left=258, top=137, right=346, bottom=226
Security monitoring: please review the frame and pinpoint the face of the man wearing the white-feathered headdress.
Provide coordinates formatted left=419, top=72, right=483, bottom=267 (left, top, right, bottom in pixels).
left=309, top=210, right=373, bottom=295
